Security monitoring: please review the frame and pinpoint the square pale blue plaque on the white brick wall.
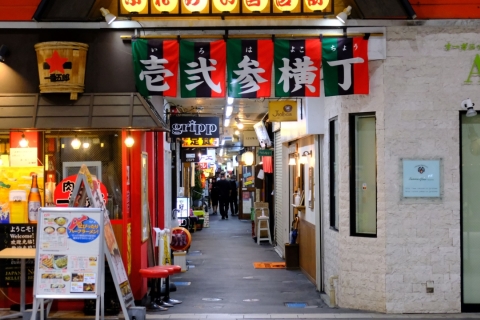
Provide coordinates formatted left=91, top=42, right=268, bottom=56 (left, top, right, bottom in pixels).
left=403, top=159, right=440, bottom=198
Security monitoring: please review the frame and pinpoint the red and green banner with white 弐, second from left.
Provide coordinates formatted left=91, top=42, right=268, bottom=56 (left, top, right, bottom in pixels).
left=180, top=40, right=226, bottom=98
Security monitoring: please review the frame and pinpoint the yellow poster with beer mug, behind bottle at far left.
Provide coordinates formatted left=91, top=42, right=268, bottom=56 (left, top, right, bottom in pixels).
left=0, top=167, right=45, bottom=223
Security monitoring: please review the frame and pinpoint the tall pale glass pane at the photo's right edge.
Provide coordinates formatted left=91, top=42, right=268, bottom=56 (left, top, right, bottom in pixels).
left=461, top=114, right=480, bottom=304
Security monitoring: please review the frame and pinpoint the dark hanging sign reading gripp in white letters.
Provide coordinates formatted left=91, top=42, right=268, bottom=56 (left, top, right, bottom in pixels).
left=170, top=116, right=220, bottom=138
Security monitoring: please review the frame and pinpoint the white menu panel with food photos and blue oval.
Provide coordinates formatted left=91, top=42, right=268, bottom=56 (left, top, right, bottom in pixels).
left=34, top=207, right=103, bottom=298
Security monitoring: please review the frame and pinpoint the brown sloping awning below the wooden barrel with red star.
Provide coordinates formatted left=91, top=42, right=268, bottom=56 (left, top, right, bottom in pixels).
left=0, top=92, right=169, bottom=131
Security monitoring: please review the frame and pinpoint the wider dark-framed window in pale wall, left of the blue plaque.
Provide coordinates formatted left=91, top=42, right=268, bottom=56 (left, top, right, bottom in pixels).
left=350, top=113, right=377, bottom=237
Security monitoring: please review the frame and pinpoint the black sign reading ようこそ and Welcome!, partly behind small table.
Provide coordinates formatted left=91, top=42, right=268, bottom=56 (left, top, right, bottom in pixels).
left=0, top=224, right=37, bottom=288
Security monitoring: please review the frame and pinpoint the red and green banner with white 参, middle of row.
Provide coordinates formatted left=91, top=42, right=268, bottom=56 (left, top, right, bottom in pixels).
left=227, top=39, right=273, bottom=98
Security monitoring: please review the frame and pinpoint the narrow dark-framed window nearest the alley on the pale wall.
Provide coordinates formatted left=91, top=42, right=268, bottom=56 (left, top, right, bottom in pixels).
left=330, top=118, right=339, bottom=230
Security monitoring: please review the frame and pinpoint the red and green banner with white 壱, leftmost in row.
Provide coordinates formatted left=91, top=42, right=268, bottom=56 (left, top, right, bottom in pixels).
left=132, top=39, right=178, bottom=97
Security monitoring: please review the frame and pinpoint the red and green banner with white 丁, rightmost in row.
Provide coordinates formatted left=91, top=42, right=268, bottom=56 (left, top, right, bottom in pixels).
left=322, top=37, right=369, bottom=97
